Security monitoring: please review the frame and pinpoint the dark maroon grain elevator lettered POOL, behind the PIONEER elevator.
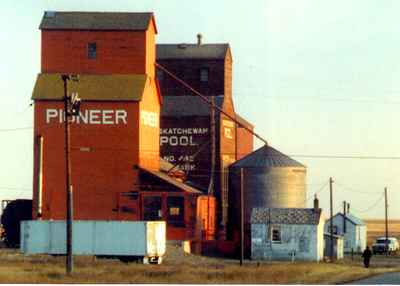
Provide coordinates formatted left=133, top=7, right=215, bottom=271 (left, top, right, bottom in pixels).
left=157, top=38, right=254, bottom=238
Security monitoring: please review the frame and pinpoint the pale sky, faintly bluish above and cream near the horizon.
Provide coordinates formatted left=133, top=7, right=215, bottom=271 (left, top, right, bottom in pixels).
left=0, top=0, right=400, bottom=218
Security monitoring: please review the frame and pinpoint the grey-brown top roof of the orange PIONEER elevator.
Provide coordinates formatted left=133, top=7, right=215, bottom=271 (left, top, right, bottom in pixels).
left=39, top=11, right=157, bottom=31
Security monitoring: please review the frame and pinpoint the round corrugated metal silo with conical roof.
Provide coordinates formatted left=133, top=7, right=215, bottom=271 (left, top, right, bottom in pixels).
left=228, top=145, right=306, bottom=241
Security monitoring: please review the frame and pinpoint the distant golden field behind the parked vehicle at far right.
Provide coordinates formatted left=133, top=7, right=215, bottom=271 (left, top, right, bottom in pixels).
left=364, top=219, right=400, bottom=245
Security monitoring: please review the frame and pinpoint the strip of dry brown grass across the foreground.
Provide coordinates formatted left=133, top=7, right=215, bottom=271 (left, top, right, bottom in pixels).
left=0, top=247, right=400, bottom=284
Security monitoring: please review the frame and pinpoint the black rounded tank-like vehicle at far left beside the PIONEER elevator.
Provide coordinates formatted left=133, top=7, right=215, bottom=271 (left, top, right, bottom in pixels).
left=1, top=200, right=32, bottom=248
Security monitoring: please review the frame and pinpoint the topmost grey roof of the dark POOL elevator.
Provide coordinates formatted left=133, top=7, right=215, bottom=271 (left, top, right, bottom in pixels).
left=156, top=44, right=230, bottom=60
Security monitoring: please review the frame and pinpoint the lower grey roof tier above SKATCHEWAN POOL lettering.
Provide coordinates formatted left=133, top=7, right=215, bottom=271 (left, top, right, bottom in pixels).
left=161, top=96, right=224, bottom=117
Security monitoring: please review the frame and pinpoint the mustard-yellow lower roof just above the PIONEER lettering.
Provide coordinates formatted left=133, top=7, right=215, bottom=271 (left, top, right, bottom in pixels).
left=32, top=73, right=147, bottom=101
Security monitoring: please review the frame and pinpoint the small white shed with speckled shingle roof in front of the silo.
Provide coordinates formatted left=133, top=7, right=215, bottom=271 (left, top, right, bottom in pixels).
left=251, top=208, right=324, bottom=261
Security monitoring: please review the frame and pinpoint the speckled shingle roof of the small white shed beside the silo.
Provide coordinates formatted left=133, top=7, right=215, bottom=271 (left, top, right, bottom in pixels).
left=251, top=208, right=322, bottom=225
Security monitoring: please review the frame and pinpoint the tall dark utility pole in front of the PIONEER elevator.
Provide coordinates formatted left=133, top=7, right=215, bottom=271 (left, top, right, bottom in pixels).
left=61, top=74, right=80, bottom=275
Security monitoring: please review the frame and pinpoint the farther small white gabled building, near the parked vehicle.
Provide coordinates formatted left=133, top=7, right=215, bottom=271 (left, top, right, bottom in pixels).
left=325, top=212, right=367, bottom=252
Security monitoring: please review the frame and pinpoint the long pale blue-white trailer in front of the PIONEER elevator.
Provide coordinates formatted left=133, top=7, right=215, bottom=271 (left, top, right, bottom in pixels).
left=20, top=220, right=166, bottom=261
